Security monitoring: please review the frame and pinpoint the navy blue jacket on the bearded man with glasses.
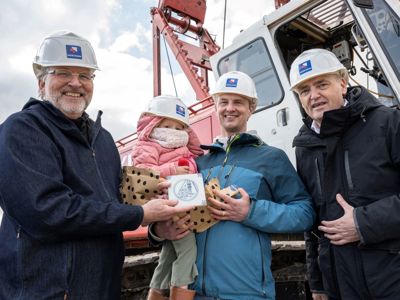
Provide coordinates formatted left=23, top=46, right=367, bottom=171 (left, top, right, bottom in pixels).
left=0, top=99, right=143, bottom=300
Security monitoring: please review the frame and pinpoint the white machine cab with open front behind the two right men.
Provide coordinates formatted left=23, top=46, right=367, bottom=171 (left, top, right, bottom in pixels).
left=211, top=0, right=400, bottom=163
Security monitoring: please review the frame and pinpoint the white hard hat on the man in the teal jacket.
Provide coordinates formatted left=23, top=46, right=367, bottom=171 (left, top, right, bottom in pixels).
left=210, top=71, right=257, bottom=102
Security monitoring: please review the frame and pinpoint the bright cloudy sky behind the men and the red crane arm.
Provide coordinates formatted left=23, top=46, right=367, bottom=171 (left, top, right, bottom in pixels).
left=0, top=0, right=274, bottom=139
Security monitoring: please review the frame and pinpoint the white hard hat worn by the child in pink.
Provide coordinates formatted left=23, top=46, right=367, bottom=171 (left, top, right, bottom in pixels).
left=143, top=95, right=189, bottom=126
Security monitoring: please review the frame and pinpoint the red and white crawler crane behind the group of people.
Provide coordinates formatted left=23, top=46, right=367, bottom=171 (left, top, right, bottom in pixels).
left=116, top=0, right=400, bottom=299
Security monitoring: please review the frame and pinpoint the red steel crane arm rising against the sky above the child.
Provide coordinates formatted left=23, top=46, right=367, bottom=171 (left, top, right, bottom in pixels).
left=151, top=0, right=220, bottom=100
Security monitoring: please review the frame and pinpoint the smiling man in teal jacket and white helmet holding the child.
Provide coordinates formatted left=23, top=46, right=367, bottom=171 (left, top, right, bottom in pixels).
left=152, top=72, right=315, bottom=300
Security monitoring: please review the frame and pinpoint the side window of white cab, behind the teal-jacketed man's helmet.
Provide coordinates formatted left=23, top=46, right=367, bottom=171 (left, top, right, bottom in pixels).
left=218, top=38, right=283, bottom=109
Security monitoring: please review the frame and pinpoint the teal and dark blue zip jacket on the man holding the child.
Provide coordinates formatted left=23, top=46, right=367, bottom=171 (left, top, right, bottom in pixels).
left=194, top=133, right=315, bottom=300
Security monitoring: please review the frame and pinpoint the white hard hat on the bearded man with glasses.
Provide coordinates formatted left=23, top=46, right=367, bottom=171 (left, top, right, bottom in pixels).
left=33, top=31, right=99, bottom=78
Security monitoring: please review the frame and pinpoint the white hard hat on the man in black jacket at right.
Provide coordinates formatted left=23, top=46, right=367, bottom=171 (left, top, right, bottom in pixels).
left=290, top=48, right=348, bottom=90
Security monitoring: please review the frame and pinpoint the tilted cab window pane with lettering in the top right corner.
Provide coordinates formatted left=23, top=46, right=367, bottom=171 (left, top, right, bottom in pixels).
left=364, top=1, right=400, bottom=78
